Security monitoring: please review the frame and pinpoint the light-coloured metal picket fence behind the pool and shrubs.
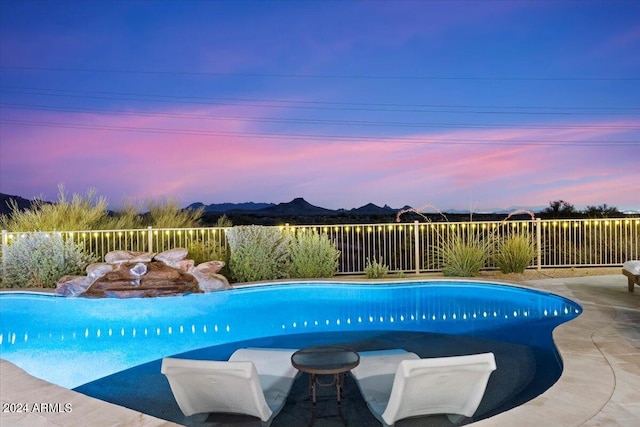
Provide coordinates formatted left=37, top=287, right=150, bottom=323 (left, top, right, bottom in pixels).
left=2, top=218, right=640, bottom=280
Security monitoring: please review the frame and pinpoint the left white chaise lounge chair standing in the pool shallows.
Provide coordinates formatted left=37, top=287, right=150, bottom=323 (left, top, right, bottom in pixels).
left=161, top=348, right=299, bottom=426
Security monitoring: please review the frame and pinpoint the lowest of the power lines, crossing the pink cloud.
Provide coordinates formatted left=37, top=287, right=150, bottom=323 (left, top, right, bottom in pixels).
left=0, top=118, right=640, bottom=147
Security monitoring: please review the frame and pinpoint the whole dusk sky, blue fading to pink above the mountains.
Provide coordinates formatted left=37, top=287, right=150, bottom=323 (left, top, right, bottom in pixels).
left=0, top=0, right=640, bottom=212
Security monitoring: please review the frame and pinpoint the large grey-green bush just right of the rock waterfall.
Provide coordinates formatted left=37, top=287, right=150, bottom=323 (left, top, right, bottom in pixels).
left=227, top=225, right=289, bottom=282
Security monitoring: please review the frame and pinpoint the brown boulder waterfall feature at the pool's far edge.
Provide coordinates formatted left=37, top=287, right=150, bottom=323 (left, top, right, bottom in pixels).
left=56, top=248, right=231, bottom=298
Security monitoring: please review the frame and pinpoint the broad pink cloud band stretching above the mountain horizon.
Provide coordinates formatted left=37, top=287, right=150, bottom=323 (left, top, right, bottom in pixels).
left=0, top=105, right=638, bottom=209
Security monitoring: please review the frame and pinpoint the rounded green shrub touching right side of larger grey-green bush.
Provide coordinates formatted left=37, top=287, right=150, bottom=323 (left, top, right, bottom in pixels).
left=289, top=230, right=340, bottom=278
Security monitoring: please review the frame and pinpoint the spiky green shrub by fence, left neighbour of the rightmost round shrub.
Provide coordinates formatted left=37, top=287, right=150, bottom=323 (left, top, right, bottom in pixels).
left=438, top=233, right=489, bottom=277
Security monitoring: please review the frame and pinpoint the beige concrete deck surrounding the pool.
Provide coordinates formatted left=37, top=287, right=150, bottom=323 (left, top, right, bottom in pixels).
left=0, top=274, right=640, bottom=427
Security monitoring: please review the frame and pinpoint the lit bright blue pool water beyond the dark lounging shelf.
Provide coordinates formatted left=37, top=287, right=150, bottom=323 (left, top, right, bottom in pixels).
left=0, top=281, right=581, bottom=388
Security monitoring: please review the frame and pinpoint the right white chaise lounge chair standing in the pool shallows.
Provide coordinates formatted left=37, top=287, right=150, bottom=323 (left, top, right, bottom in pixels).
left=351, top=350, right=496, bottom=427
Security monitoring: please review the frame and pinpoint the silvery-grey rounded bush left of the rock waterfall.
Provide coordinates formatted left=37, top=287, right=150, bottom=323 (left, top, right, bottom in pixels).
left=2, top=233, right=96, bottom=288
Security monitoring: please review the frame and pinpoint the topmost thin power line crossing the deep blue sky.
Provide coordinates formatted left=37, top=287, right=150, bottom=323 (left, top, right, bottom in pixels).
left=0, top=66, right=640, bottom=82
